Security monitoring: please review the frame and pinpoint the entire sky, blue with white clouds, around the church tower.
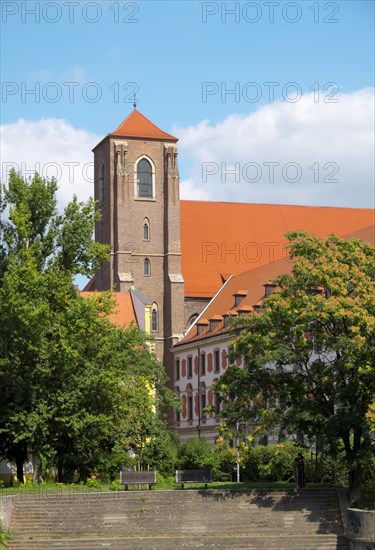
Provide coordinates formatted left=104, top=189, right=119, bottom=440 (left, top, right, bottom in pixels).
left=1, top=0, right=374, bottom=215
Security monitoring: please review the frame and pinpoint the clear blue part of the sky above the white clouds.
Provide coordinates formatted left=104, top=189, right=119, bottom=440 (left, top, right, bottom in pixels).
left=2, top=0, right=374, bottom=130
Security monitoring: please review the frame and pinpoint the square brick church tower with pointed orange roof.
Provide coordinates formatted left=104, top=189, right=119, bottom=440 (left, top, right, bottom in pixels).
left=93, top=108, right=184, bottom=381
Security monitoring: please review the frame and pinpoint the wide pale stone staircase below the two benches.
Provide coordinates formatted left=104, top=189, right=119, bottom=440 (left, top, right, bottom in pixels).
left=7, top=489, right=349, bottom=550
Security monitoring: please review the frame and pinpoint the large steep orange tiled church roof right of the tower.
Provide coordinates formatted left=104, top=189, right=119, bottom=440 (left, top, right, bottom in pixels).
left=181, top=201, right=375, bottom=297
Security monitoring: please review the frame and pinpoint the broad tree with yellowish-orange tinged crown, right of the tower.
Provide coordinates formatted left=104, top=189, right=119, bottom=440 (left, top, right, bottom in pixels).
left=217, top=232, right=375, bottom=499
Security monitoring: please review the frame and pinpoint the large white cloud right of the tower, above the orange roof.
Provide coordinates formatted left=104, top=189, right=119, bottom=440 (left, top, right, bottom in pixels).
left=173, top=89, right=374, bottom=207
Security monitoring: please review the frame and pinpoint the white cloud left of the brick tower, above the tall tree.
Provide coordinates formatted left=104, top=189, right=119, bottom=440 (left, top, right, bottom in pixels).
left=0, top=119, right=103, bottom=209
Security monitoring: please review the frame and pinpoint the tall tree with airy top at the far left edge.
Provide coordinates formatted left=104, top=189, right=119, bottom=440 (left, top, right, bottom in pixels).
left=0, top=171, right=107, bottom=481
